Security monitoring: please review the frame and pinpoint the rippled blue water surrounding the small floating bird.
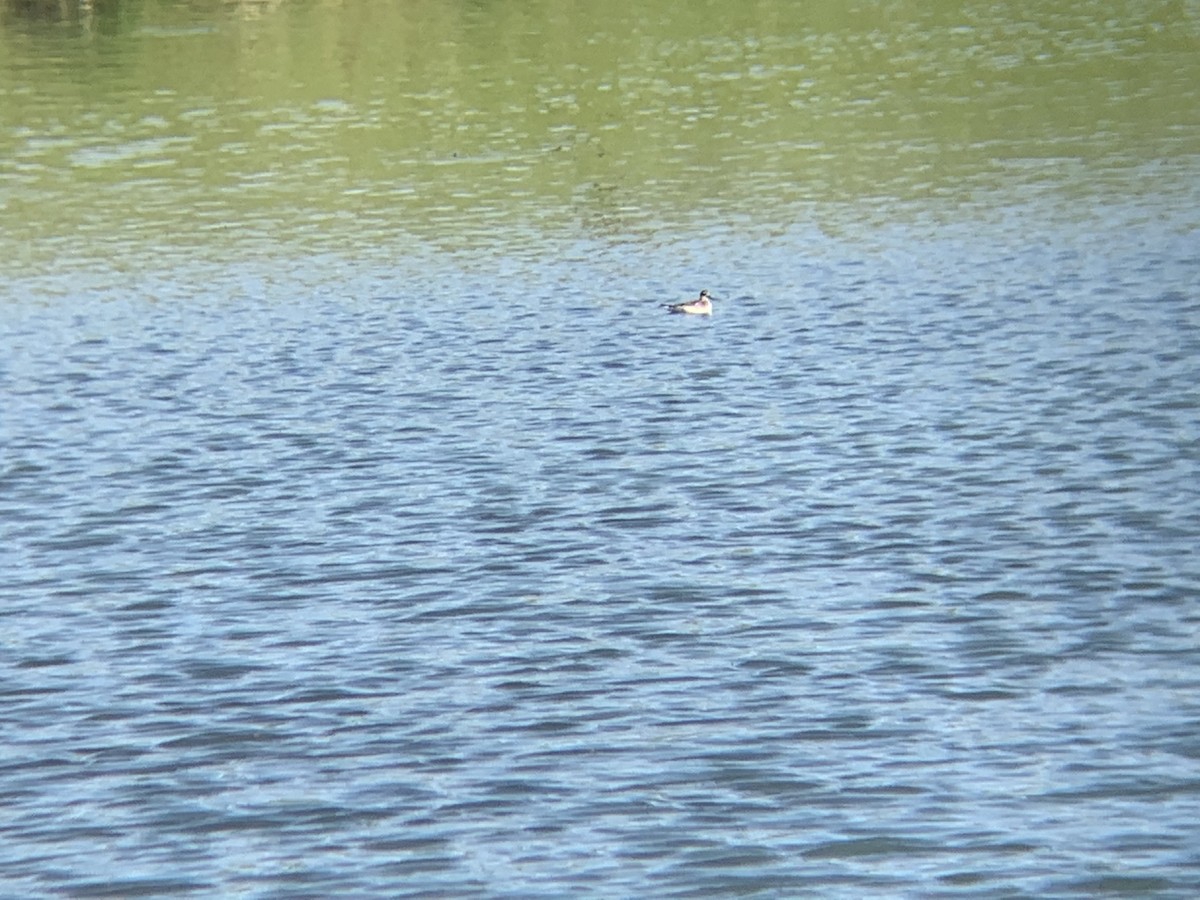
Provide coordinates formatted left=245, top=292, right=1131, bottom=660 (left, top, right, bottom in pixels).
left=0, top=210, right=1200, bottom=898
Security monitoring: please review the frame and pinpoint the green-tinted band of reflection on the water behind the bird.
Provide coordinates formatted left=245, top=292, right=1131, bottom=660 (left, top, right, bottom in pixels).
left=0, top=0, right=1200, bottom=265
